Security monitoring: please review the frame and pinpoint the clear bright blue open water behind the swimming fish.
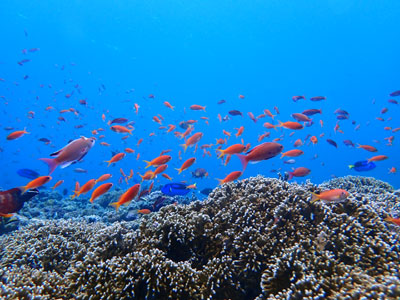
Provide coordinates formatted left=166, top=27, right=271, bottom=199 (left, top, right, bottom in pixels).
left=0, top=0, right=400, bottom=195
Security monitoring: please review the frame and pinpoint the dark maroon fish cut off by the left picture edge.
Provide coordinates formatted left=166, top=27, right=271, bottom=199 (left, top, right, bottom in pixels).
left=0, top=188, right=39, bottom=215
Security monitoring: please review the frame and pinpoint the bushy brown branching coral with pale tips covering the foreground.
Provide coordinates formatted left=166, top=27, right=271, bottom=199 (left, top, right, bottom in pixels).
left=0, top=177, right=400, bottom=300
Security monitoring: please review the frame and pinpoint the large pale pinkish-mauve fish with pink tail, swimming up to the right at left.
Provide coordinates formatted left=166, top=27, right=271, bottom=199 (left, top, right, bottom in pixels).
left=39, top=136, right=95, bottom=174
